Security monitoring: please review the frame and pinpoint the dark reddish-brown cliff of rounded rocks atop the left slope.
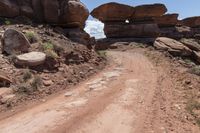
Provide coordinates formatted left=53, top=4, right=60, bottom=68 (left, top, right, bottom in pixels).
left=0, top=0, right=89, bottom=28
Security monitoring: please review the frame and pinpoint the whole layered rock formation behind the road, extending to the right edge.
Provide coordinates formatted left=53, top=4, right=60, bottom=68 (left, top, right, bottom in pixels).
left=91, top=2, right=200, bottom=39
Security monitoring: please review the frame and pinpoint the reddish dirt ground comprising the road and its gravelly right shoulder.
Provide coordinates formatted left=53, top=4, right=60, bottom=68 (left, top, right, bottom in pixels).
left=0, top=43, right=200, bottom=133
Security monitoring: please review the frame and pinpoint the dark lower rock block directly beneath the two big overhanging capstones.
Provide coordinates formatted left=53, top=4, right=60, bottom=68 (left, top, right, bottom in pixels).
left=104, top=23, right=160, bottom=38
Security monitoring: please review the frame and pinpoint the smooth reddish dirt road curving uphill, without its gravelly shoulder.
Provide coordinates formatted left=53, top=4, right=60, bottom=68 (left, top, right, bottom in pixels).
left=0, top=51, right=198, bottom=133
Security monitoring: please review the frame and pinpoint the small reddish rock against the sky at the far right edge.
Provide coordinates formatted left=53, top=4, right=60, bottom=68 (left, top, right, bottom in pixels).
left=181, top=16, right=200, bottom=27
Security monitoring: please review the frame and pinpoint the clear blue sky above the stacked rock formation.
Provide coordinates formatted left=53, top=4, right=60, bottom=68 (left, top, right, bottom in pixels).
left=81, top=0, right=200, bottom=19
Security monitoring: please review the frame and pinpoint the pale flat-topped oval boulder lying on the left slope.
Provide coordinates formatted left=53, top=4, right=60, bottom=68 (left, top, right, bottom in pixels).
left=15, top=52, right=46, bottom=67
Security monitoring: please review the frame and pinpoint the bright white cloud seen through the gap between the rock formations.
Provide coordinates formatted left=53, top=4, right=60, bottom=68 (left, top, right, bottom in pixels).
left=85, top=20, right=106, bottom=39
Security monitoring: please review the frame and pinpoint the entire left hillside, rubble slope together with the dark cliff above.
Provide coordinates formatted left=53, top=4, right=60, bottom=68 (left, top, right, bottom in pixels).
left=0, top=0, right=105, bottom=112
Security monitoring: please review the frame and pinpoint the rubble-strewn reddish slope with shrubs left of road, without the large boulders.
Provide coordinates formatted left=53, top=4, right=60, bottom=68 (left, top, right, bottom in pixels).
left=0, top=24, right=105, bottom=112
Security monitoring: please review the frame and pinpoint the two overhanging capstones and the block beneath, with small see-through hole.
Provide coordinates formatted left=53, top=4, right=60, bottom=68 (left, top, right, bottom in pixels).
left=91, top=2, right=167, bottom=38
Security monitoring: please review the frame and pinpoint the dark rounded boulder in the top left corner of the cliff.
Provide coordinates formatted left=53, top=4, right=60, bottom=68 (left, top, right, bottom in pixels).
left=0, top=0, right=20, bottom=17
